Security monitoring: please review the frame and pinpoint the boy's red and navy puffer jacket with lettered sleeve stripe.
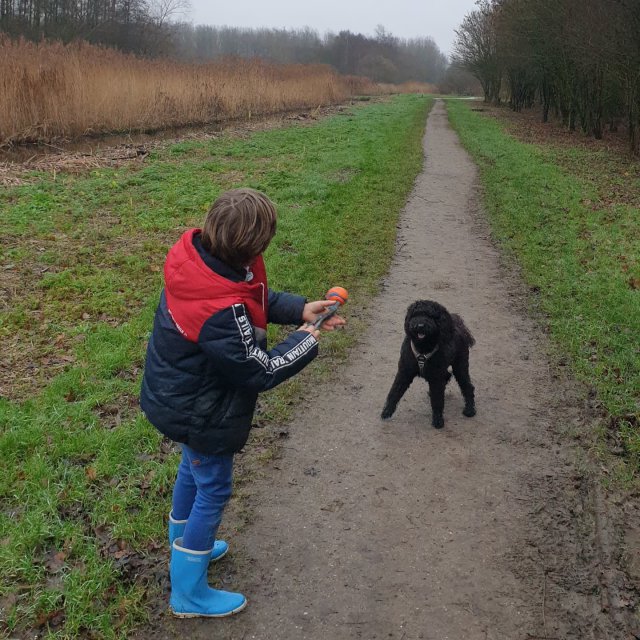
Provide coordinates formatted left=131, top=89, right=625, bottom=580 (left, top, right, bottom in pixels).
left=140, top=229, right=318, bottom=455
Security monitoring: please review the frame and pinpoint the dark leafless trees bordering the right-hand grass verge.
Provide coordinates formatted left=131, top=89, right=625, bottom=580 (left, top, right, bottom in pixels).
left=453, top=0, right=640, bottom=154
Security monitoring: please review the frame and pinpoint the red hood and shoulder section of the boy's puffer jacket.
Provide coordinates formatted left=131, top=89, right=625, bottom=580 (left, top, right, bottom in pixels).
left=164, top=229, right=267, bottom=342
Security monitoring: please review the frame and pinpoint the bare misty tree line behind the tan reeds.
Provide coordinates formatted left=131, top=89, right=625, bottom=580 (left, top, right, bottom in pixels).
left=0, top=0, right=448, bottom=83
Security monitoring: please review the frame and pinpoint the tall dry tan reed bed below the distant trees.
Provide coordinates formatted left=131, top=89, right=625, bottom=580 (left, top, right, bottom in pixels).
left=0, top=38, right=386, bottom=144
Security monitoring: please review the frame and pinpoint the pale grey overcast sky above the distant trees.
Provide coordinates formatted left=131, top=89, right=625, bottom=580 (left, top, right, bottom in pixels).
left=185, top=0, right=475, bottom=54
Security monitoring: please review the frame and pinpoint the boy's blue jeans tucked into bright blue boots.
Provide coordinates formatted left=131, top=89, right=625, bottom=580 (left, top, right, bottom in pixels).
left=172, top=444, right=233, bottom=551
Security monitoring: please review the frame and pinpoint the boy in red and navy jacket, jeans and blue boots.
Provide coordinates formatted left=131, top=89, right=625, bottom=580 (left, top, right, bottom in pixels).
left=140, top=189, right=344, bottom=617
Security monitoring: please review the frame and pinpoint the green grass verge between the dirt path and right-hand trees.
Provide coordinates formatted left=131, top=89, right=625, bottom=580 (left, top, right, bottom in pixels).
left=448, top=100, right=640, bottom=485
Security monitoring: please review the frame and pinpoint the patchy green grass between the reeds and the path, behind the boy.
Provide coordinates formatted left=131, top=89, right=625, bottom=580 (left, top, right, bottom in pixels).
left=0, top=96, right=431, bottom=638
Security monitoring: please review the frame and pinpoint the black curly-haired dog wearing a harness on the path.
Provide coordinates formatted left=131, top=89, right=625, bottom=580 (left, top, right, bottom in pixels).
left=382, top=300, right=476, bottom=429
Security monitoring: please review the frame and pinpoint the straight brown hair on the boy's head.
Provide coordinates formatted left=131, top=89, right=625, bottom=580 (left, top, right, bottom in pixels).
left=202, top=188, right=276, bottom=269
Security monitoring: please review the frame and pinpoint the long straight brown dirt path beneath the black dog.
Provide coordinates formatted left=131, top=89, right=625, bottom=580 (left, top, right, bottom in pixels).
left=153, top=101, right=628, bottom=640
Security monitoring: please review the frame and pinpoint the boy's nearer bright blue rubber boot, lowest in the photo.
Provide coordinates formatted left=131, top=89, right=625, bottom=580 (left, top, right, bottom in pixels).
left=169, top=538, right=247, bottom=618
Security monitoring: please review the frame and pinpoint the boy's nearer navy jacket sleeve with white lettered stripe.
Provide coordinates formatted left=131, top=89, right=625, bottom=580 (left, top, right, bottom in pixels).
left=198, top=304, right=318, bottom=391
